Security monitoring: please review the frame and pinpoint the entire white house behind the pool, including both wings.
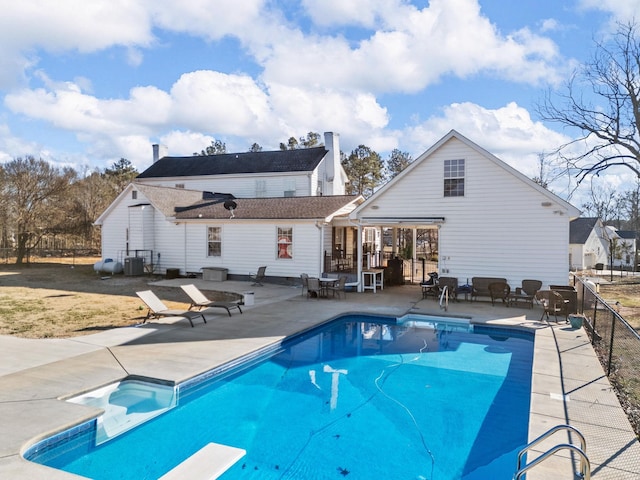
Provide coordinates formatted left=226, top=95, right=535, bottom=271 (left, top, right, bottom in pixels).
left=97, top=127, right=580, bottom=287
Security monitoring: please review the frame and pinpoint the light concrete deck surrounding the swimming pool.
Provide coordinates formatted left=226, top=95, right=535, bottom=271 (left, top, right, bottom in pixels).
left=0, top=279, right=640, bottom=480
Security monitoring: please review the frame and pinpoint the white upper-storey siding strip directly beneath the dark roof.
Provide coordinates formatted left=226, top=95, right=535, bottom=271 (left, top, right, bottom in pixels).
left=137, top=173, right=316, bottom=198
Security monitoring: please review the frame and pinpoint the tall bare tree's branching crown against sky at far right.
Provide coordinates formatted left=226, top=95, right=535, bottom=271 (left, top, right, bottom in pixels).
left=537, top=22, right=640, bottom=183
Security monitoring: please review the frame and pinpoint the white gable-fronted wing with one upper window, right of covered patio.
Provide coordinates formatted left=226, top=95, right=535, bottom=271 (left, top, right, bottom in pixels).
left=349, top=130, right=580, bottom=288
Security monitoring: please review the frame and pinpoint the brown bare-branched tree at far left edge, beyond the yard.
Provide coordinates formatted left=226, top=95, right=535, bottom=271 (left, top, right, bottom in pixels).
left=3, top=157, right=76, bottom=265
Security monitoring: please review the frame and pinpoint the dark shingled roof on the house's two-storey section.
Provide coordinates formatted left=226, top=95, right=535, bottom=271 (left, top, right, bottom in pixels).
left=136, top=147, right=328, bottom=178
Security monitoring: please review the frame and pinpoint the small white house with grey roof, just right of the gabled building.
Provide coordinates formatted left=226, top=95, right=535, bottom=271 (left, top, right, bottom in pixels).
left=569, top=217, right=609, bottom=270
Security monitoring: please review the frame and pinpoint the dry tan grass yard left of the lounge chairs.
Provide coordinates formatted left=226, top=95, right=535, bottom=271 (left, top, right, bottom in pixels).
left=0, top=258, right=202, bottom=338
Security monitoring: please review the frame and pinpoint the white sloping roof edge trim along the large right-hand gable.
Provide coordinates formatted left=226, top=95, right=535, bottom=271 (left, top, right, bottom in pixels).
left=351, top=130, right=580, bottom=217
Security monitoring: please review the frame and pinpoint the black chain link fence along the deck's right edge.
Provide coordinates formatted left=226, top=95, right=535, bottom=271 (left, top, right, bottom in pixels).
left=573, top=276, right=640, bottom=436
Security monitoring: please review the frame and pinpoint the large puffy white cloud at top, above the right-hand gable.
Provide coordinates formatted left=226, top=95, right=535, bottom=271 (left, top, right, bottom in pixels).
left=263, top=0, right=561, bottom=93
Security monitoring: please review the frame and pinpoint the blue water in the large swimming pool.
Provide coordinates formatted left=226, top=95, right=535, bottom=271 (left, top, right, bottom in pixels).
left=25, top=315, right=533, bottom=480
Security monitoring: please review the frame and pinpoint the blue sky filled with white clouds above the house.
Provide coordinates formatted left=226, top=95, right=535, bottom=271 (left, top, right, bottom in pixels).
left=0, top=0, right=640, bottom=207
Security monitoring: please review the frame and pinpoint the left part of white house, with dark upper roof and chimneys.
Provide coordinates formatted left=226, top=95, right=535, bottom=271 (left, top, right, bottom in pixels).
left=96, top=133, right=363, bottom=279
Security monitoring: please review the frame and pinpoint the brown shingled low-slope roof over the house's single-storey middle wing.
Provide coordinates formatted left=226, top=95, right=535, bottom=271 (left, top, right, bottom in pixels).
left=175, top=195, right=363, bottom=221
